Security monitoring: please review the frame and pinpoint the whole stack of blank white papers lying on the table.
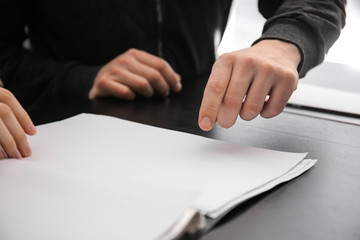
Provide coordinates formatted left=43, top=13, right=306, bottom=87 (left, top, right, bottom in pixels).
left=0, top=114, right=316, bottom=240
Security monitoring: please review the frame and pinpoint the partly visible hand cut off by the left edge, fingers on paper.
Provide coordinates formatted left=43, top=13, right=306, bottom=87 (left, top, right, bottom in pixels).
left=0, top=87, right=36, bottom=159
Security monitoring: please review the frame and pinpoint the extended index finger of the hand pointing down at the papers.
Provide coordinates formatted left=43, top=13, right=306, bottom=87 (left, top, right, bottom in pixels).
left=198, top=59, right=232, bottom=131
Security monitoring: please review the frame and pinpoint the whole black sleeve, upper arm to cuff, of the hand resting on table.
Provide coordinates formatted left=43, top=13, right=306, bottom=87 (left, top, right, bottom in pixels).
left=0, top=0, right=100, bottom=110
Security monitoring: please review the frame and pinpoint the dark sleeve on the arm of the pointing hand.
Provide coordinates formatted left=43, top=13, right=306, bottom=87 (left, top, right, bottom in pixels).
left=255, top=0, right=346, bottom=77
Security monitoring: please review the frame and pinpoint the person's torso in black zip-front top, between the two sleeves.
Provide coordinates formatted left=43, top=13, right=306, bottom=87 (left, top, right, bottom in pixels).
left=27, top=0, right=231, bottom=75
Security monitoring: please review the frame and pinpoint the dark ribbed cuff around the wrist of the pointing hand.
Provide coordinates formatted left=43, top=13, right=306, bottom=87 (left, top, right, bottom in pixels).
left=253, top=19, right=324, bottom=78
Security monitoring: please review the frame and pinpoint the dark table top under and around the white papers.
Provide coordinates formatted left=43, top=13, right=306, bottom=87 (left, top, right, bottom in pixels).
left=30, top=78, right=360, bottom=240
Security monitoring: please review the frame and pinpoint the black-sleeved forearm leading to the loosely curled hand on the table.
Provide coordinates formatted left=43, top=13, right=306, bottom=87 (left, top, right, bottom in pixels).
left=0, top=46, right=99, bottom=109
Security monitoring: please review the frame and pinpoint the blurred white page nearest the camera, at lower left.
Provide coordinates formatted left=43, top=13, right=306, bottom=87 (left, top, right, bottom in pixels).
left=0, top=160, right=197, bottom=240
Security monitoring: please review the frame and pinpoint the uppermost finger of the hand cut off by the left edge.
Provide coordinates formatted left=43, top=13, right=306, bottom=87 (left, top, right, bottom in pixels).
left=0, top=88, right=36, bottom=135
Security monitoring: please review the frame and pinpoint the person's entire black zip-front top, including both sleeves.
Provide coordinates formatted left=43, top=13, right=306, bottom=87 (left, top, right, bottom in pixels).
left=0, top=0, right=346, bottom=108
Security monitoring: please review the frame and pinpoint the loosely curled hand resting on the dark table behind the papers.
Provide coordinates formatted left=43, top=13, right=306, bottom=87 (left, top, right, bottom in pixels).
left=89, top=49, right=181, bottom=100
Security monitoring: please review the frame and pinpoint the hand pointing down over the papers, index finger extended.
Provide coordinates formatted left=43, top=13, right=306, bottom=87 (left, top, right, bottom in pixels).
left=199, top=40, right=301, bottom=131
